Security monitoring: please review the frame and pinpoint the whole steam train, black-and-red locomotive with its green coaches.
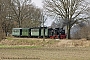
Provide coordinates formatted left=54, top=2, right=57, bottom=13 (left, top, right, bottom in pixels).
left=12, top=27, right=66, bottom=39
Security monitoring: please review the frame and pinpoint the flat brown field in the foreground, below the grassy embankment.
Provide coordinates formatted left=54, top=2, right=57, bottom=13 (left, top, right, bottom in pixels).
left=0, top=47, right=90, bottom=60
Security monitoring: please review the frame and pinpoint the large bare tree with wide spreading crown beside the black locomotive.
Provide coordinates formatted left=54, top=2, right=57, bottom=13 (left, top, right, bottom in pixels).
left=43, top=0, right=89, bottom=39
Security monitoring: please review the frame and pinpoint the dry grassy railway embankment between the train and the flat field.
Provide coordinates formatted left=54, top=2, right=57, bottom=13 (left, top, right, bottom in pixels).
left=0, top=37, right=90, bottom=47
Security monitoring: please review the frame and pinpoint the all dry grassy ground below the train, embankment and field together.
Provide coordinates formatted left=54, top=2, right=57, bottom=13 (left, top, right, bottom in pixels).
left=0, top=38, right=90, bottom=60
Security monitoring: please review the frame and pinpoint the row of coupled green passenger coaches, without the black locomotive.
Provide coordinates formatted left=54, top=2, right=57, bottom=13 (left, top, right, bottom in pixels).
left=12, top=27, right=52, bottom=37
